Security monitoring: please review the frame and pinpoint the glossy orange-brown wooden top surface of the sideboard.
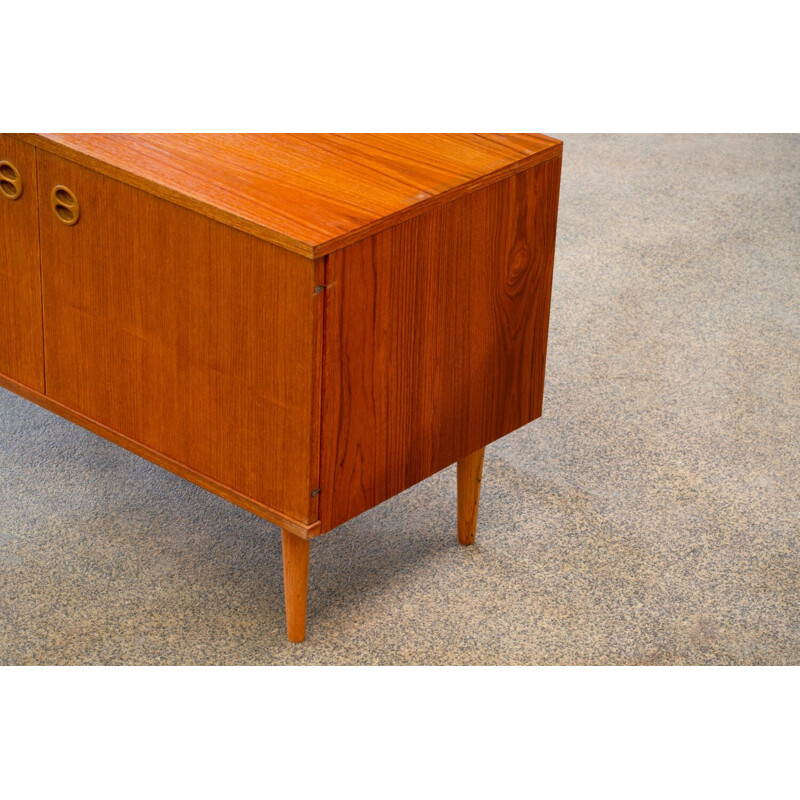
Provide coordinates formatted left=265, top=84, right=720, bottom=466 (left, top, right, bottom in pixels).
left=20, top=133, right=561, bottom=257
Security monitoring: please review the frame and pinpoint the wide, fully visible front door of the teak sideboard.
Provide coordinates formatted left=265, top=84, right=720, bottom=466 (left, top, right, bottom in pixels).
left=39, top=151, right=321, bottom=522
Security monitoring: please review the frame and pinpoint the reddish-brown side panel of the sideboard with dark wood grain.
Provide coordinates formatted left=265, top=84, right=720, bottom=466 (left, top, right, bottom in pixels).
left=320, top=157, right=561, bottom=530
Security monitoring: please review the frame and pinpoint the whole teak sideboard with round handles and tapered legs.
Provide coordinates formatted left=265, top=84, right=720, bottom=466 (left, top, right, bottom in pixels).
left=0, top=134, right=562, bottom=641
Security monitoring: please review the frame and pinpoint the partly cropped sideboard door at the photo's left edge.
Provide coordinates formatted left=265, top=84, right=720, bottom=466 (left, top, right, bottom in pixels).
left=0, top=134, right=44, bottom=392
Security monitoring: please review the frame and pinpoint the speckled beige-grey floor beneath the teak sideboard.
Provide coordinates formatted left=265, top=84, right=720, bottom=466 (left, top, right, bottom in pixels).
left=0, top=136, right=800, bottom=664
